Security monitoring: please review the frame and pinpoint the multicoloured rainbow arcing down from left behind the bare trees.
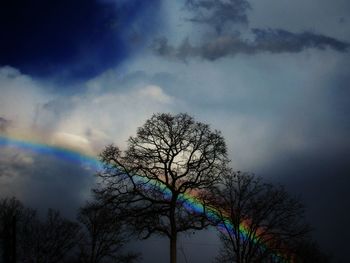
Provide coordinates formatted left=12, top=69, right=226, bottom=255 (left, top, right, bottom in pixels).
left=0, top=135, right=291, bottom=263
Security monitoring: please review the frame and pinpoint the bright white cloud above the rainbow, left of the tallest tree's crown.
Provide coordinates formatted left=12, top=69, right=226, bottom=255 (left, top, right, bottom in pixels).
left=0, top=67, right=175, bottom=154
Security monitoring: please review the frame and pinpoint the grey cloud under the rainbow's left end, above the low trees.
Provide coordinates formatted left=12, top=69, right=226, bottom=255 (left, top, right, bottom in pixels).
left=0, top=148, right=95, bottom=218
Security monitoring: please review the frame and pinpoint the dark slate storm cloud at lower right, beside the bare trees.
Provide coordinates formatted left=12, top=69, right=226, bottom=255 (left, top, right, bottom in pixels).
left=262, top=150, right=350, bottom=262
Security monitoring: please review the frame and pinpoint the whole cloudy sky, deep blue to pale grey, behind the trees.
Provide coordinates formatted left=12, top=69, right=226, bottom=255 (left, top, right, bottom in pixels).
left=0, top=0, right=350, bottom=262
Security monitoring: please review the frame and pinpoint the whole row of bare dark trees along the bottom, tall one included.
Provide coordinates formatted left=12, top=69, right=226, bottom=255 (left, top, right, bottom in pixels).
left=0, top=114, right=330, bottom=263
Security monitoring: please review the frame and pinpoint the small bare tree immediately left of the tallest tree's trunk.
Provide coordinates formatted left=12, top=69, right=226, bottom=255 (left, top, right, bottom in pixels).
left=78, top=203, right=138, bottom=263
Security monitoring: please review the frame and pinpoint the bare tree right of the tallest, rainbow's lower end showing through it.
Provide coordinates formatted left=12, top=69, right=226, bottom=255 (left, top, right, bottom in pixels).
left=214, top=172, right=309, bottom=263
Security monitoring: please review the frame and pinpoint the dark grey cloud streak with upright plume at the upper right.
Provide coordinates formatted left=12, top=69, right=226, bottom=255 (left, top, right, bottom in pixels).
left=157, top=0, right=349, bottom=61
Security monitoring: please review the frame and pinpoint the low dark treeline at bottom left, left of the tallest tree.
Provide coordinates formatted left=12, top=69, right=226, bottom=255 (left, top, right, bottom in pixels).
left=0, top=198, right=139, bottom=263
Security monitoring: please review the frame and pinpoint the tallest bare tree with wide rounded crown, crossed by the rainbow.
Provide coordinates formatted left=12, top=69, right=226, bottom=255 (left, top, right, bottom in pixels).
left=96, top=114, right=227, bottom=263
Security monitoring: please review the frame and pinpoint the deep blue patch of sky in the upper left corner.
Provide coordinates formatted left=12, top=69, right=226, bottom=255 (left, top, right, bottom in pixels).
left=0, top=0, right=159, bottom=80
